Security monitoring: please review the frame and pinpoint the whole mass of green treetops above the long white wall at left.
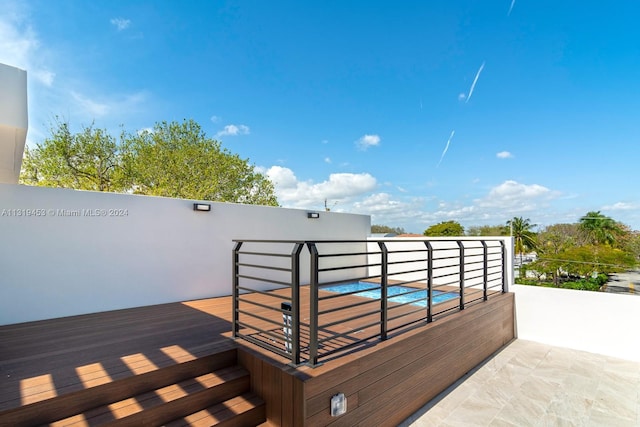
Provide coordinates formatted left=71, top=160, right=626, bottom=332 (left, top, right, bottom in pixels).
left=21, top=120, right=278, bottom=206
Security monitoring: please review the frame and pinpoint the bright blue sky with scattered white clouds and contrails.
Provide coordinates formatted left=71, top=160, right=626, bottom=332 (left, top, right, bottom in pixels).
left=0, top=0, right=640, bottom=233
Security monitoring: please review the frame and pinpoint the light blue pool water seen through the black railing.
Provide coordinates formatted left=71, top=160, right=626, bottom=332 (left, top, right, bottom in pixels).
left=321, top=282, right=458, bottom=307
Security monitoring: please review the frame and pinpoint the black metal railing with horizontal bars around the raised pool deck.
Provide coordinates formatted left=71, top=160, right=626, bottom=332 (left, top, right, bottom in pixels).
left=232, top=238, right=508, bottom=366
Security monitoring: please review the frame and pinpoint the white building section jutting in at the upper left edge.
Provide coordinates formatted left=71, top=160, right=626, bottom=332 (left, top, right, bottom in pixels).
left=0, top=64, right=28, bottom=184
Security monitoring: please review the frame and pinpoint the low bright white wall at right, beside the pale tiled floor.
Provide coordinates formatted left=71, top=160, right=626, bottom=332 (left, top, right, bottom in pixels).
left=511, top=285, right=640, bottom=362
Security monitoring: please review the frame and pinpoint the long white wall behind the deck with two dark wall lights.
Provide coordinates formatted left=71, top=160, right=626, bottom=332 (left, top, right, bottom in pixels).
left=0, top=184, right=371, bottom=325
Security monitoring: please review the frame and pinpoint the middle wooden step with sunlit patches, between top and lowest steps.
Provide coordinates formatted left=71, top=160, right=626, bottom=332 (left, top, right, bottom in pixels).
left=51, top=366, right=250, bottom=427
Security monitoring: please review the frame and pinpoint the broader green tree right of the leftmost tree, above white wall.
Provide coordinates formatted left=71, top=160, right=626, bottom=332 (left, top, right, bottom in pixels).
left=124, top=120, right=278, bottom=206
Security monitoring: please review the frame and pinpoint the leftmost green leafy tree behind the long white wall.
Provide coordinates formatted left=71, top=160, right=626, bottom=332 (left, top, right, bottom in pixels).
left=20, top=119, right=126, bottom=192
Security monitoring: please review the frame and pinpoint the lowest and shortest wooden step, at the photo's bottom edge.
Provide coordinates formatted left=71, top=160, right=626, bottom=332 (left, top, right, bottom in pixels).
left=165, top=393, right=266, bottom=427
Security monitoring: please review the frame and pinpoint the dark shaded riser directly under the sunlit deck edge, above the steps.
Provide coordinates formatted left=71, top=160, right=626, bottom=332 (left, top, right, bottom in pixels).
left=0, top=349, right=237, bottom=427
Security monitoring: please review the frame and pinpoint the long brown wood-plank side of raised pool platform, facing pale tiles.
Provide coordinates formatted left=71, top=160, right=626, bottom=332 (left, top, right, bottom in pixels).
left=305, top=295, right=514, bottom=426
